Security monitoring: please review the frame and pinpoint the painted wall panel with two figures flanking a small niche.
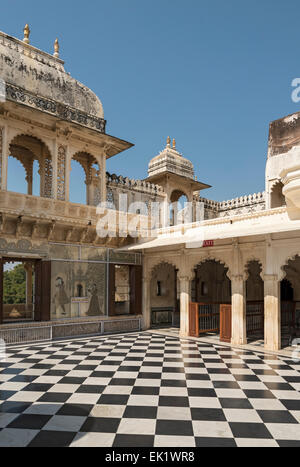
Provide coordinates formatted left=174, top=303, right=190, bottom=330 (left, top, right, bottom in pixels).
left=51, top=261, right=106, bottom=319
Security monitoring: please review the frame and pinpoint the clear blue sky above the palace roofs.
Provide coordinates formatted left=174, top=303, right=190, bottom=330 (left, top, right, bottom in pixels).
left=0, top=0, right=300, bottom=201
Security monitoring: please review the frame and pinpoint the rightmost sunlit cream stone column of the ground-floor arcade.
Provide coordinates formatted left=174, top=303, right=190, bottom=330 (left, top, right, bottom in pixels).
left=264, top=274, right=281, bottom=350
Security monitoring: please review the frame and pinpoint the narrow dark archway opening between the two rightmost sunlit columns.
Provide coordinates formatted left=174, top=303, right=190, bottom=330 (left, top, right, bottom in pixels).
left=246, top=260, right=264, bottom=346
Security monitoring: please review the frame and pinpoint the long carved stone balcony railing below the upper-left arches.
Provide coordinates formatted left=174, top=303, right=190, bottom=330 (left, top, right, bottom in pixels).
left=0, top=190, right=151, bottom=239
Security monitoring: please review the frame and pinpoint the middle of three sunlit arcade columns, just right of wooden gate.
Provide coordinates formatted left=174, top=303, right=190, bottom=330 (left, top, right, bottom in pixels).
left=231, top=275, right=247, bottom=345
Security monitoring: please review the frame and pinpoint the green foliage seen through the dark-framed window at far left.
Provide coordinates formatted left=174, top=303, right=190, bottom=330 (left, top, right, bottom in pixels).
left=3, top=264, right=26, bottom=305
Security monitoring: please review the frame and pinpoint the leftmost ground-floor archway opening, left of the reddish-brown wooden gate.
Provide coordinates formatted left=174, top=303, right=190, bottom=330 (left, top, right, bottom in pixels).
left=150, top=263, right=180, bottom=328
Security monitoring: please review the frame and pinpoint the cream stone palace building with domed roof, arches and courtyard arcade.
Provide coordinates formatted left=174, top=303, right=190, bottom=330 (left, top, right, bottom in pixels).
left=0, top=25, right=300, bottom=351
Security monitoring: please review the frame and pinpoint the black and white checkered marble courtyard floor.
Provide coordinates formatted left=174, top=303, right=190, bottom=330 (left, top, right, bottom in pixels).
left=0, top=333, right=300, bottom=447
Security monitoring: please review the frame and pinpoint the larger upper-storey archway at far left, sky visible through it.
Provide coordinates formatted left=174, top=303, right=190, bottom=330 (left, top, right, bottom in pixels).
left=7, top=135, right=53, bottom=198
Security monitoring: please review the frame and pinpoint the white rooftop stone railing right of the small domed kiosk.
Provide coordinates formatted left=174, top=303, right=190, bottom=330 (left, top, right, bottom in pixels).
left=195, top=192, right=266, bottom=218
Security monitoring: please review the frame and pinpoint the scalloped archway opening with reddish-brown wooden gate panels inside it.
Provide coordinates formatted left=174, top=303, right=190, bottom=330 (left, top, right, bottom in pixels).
left=190, top=260, right=231, bottom=342
